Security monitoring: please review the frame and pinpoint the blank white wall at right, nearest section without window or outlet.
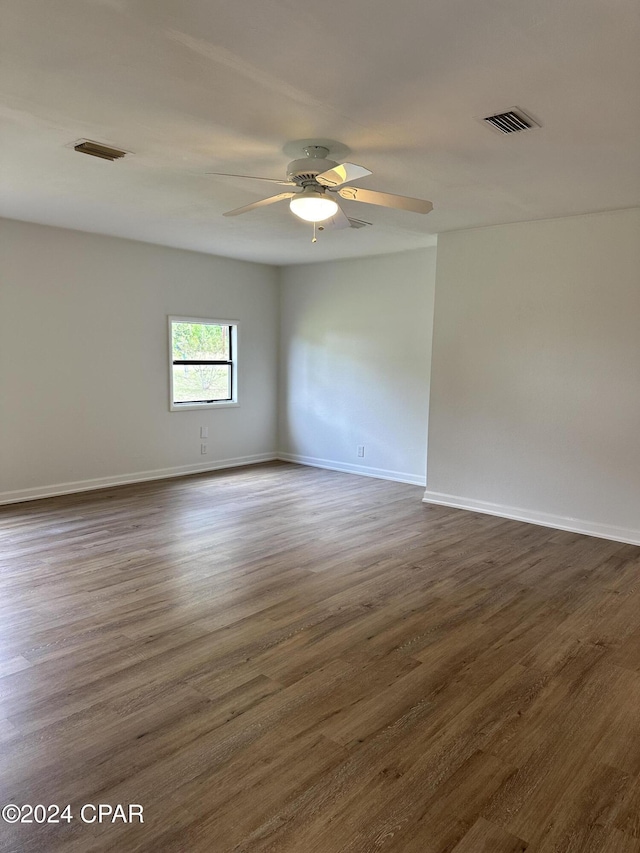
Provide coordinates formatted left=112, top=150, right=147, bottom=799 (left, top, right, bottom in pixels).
left=425, top=209, right=640, bottom=544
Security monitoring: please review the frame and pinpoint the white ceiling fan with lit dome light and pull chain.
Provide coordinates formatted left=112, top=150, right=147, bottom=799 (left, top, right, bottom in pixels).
left=208, top=145, right=433, bottom=233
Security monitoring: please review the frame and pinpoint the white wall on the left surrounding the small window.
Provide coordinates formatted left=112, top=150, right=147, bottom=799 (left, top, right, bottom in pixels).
left=0, top=220, right=278, bottom=502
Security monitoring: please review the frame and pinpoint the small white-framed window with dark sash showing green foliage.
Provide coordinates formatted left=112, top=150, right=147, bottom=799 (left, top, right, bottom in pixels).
left=169, top=317, right=238, bottom=411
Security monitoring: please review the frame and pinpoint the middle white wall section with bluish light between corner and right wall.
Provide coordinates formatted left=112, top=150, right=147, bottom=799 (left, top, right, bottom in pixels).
left=280, top=249, right=435, bottom=484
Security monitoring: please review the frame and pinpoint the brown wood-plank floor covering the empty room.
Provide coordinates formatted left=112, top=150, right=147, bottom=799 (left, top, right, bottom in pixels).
left=0, top=463, right=640, bottom=853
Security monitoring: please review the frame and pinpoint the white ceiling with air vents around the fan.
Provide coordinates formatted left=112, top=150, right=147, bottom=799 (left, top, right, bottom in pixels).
left=0, top=0, right=640, bottom=264
